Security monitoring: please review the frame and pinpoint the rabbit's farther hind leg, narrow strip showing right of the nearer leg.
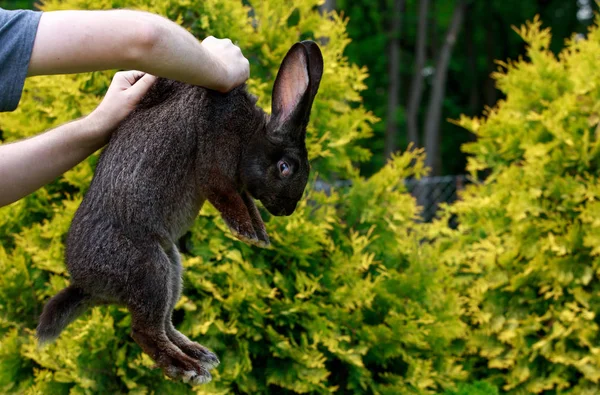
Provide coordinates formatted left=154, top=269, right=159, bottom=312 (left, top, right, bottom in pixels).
left=165, top=245, right=220, bottom=370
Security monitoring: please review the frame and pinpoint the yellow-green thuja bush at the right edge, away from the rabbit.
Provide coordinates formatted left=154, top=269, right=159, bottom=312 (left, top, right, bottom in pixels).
left=431, top=15, right=600, bottom=394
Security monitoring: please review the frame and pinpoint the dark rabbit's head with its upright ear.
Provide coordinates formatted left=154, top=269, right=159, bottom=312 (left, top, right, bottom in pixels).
left=241, top=41, right=323, bottom=215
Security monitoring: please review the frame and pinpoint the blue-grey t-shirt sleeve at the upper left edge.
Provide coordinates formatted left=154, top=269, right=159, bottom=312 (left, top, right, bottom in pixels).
left=0, top=8, right=42, bottom=112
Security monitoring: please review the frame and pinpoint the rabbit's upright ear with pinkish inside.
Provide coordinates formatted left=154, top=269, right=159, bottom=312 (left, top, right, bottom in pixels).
left=268, top=41, right=323, bottom=141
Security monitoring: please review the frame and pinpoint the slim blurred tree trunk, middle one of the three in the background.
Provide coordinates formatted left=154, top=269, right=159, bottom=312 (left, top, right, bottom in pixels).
left=406, top=0, right=429, bottom=146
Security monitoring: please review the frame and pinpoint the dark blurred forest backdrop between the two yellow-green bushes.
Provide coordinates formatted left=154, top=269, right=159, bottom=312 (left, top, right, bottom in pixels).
left=338, top=0, right=598, bottom=175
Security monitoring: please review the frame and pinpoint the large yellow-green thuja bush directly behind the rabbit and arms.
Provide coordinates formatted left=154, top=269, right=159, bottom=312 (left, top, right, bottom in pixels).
left=0, top=0, right=466, bottom=394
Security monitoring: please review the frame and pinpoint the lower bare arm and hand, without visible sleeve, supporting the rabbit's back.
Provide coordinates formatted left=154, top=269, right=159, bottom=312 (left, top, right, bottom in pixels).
left=0, top=71, right=155, bottom=207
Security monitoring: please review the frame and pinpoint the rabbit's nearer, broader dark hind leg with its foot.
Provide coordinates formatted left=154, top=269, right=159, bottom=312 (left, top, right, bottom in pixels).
left=127, top=246, right=211, bottom=384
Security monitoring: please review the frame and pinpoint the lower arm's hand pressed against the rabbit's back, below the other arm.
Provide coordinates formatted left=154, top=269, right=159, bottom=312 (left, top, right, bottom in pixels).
left=86, top=70, right=156, bottom=143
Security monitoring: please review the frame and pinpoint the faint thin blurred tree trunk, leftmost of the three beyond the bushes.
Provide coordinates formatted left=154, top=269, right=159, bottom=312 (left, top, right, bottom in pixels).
left=384, top=0, right=405, bottom=158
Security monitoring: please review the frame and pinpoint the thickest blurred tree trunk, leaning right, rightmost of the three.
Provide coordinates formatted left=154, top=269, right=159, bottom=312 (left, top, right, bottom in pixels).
left=425, top=0, right=466, bottom=175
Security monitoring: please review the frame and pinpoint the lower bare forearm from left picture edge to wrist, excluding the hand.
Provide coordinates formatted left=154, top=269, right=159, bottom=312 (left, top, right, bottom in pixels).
left=0, top=117, right=106, bottom=207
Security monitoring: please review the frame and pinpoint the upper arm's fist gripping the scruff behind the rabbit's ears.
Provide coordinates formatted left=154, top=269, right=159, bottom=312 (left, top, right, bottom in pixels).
left=202, top=36, right=250, bottom=92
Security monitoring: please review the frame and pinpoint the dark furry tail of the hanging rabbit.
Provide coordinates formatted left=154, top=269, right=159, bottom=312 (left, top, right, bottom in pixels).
left=36, top=285, right=90, bottom=344
